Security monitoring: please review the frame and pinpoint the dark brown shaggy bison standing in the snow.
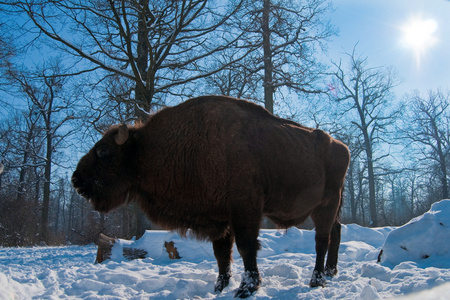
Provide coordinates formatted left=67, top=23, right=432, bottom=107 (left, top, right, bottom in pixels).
left=72, top=96, right=350, bottom=298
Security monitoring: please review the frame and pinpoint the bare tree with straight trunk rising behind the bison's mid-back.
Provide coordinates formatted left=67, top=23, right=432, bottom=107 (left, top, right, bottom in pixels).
left=221, top=0, right=336, bottom=112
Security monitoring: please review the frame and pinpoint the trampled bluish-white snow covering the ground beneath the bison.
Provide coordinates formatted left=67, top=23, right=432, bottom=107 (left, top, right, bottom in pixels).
left=0, top=200, right=450, bottom=300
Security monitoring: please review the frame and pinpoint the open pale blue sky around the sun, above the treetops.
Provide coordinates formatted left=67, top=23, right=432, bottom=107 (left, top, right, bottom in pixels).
left=328, top=0, right=450, bottom=96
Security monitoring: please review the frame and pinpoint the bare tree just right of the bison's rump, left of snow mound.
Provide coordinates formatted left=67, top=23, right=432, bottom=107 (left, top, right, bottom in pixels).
left=330, top=49, right=400, bottom=226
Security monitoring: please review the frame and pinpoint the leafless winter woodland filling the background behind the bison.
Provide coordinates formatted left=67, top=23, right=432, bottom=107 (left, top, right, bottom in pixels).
left=0, top=0, right=450, bottom=246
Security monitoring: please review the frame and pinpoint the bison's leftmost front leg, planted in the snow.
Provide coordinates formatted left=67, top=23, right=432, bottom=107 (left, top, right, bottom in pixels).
left=213, top=232, right=234, bottom=293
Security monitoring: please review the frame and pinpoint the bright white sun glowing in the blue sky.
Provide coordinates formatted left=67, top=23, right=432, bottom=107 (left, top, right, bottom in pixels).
left=401, top=17, right=438, bottom=66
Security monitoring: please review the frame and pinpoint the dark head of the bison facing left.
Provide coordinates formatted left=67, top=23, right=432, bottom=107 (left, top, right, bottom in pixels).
left=72, top=125, right=136, bottom=212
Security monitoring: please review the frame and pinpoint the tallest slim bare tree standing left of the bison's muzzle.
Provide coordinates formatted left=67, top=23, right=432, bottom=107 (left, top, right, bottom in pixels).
left=6, top=62, right=76, bottom=242
